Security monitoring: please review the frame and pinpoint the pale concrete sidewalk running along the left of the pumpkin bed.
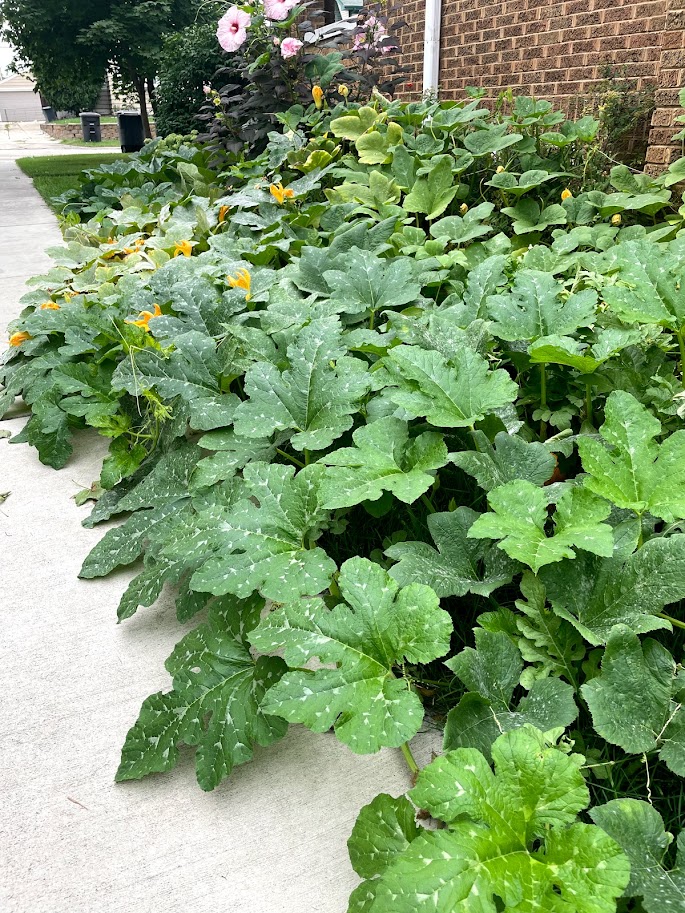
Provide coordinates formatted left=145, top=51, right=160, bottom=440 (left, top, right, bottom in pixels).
left=0, top=155, right=434, bottom=913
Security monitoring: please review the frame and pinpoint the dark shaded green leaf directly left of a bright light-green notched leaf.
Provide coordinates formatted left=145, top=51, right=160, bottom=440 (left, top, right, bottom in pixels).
left=385, top=507, right=516, bottom=597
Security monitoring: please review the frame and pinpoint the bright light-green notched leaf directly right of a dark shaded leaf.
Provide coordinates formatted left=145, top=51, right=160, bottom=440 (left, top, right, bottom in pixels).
left=468, top=480, right=614, bottom=573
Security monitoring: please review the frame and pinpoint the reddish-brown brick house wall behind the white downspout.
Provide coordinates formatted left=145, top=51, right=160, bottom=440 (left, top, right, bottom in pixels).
left=392, top=0, right=685, bottom=165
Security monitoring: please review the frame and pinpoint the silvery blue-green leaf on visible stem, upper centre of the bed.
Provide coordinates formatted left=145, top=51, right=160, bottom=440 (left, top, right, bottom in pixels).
left=323, top=247, right=421, bottom=314
